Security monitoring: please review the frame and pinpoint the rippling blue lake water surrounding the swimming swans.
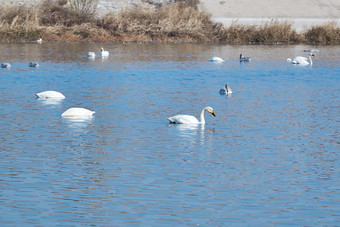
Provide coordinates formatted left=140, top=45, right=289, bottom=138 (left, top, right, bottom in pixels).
left=0, top=43, right=340, bottom=226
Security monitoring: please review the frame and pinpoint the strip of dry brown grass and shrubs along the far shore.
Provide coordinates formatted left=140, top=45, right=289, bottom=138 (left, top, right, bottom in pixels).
left=0, top=0, right=340, bottom=44
